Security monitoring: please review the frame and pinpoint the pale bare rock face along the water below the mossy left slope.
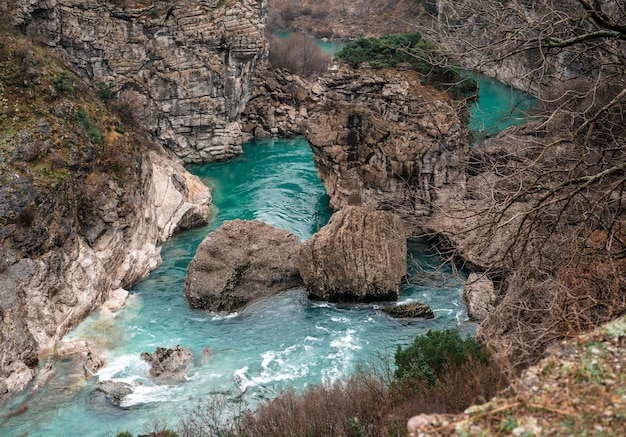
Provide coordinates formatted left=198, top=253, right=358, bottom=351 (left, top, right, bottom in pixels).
left=0, top=152, right=211, bottom=398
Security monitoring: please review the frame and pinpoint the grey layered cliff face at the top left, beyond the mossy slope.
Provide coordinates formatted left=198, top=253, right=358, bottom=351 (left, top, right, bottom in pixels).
left=13, top=0, right=267, bottom=163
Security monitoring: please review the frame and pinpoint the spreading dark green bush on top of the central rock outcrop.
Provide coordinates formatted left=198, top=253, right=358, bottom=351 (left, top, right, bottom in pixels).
left=335, top=32, right=477, bottom=98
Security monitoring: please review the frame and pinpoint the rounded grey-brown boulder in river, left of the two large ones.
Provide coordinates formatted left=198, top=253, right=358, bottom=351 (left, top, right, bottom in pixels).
left=185, top=220, right=302, bottom=312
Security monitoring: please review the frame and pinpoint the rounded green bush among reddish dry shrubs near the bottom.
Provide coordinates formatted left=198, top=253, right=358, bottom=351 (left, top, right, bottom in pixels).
left=394, top=329, right=489, bottom=387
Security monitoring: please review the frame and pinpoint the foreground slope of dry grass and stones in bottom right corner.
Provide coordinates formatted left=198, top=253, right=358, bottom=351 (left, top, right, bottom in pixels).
left=408, top=317, right=626, bottom=436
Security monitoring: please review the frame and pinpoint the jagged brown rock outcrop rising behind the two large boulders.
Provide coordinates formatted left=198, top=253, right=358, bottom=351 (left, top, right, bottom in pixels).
left=307, top=68, right=469, bottom=228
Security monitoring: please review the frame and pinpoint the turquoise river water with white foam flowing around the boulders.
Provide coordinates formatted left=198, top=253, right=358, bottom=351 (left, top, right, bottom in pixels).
left=0, top=79, right=532, bottom=437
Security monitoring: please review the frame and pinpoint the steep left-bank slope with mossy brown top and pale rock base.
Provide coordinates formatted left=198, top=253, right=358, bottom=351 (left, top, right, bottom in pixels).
left=0, top=32, right=211, bottom=399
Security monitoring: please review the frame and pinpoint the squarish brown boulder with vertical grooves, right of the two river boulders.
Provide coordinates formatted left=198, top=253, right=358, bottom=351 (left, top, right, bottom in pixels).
left=300, top=206, right=407, bottom=302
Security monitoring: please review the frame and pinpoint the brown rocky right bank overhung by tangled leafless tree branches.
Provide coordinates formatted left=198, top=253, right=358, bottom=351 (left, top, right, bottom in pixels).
left=424, top=0, right=626, bottom=364
